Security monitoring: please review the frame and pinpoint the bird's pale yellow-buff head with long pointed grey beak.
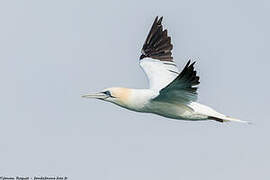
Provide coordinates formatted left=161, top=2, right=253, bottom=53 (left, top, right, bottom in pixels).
left=82, top=87, right=130, bottom=106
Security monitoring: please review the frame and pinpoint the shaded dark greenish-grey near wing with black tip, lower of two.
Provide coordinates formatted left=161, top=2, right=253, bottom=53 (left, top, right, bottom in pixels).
left=153, top=61, right=200, bottom=103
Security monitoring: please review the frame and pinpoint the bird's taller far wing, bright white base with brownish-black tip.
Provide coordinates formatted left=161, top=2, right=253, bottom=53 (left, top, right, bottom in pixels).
left=140, top=17, right=179, bottom=90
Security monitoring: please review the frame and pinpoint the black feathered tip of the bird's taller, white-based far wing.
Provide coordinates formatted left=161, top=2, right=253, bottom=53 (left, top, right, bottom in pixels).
left=140, top=16, right=173, bottom=61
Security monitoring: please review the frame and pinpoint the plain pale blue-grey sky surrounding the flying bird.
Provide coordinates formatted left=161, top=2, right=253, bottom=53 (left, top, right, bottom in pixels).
left=0, top=0, right=270, bottom=180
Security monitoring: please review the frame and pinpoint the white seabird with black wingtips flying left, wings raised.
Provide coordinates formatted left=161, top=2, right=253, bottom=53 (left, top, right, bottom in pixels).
left=82, top=17, right=246, bottom=122
